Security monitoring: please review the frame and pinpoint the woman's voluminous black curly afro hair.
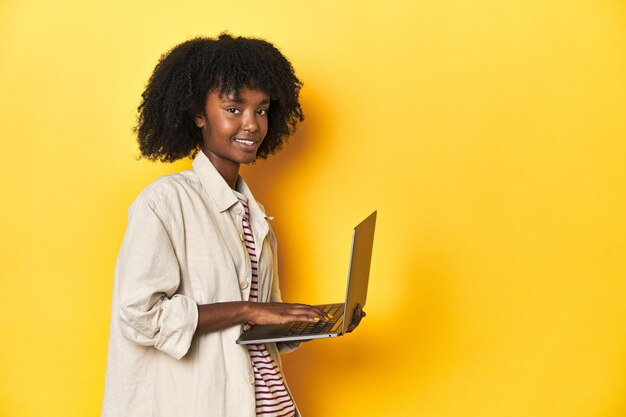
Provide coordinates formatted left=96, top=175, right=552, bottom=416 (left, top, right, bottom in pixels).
left=135, top=33, right=304, bottom=162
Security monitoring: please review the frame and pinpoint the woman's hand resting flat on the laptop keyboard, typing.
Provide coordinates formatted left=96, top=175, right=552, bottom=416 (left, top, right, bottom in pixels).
left=246, top=303, right=330, bottom=324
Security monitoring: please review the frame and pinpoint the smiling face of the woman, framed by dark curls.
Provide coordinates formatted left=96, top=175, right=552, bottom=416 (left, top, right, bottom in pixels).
left=195, top=88, right=270, bottom=175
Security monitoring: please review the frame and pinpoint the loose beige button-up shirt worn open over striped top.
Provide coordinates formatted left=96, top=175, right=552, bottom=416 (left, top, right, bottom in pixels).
left=102, top=152, right=298, bottom=417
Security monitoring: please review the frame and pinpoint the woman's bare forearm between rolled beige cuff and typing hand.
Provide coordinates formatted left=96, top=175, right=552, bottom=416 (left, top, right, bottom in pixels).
left=196, top=301, right=252, bottom=334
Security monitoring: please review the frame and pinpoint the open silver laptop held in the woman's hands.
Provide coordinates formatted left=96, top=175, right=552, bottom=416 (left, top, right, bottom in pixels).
left=237, top=211, right=376, bottom=345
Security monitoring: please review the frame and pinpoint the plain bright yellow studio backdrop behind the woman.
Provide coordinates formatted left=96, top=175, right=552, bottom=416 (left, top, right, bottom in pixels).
left=0, top=0, right=626, bottom=417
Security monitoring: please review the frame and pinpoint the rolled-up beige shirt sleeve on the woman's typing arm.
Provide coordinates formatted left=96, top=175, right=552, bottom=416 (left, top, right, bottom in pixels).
left=118, top=193, right=198, bottom=359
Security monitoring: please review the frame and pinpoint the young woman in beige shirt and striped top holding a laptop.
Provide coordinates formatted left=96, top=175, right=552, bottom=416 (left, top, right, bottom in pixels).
left=102, top=34, right=358, bottom=417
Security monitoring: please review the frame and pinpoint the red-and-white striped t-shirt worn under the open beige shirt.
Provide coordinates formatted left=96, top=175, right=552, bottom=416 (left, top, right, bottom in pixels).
left=235, top=192, right=296, bottom=417
